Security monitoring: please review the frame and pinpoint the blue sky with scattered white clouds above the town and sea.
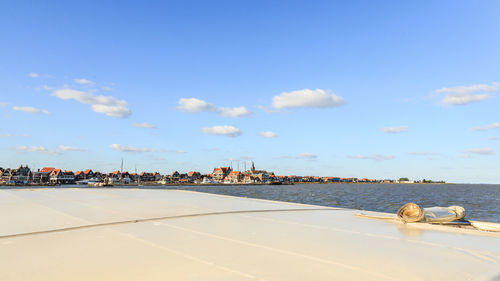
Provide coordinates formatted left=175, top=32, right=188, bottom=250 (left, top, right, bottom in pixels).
left=0, top=0, right=500, bottom=183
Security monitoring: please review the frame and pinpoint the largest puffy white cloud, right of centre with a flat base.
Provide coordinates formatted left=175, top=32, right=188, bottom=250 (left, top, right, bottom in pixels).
left=272, top=89, right=344, bottom=109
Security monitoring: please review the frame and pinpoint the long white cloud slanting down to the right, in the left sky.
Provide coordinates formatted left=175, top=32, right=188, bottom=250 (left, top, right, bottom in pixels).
left=52, top=89, right=132, bottom=118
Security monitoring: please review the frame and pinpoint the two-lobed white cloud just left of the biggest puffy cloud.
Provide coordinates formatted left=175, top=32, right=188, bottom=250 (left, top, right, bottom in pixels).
left=177, top=98, right=253, bottom=118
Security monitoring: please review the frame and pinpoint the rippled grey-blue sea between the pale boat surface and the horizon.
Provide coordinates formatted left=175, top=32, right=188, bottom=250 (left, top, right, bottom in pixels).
left=0, top=184, right=500, bottom=222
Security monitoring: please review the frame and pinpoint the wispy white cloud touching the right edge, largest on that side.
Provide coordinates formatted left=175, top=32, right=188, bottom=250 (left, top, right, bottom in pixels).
left=434, top=82, right=500, bottom=105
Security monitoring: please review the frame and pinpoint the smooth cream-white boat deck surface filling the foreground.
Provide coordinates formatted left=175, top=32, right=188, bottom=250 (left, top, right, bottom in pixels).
left=0, top=188, right=500, bottom=281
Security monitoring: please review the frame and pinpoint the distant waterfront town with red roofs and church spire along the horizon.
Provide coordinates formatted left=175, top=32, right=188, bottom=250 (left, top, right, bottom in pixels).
left=0, top=162, right=444, bottom=186
